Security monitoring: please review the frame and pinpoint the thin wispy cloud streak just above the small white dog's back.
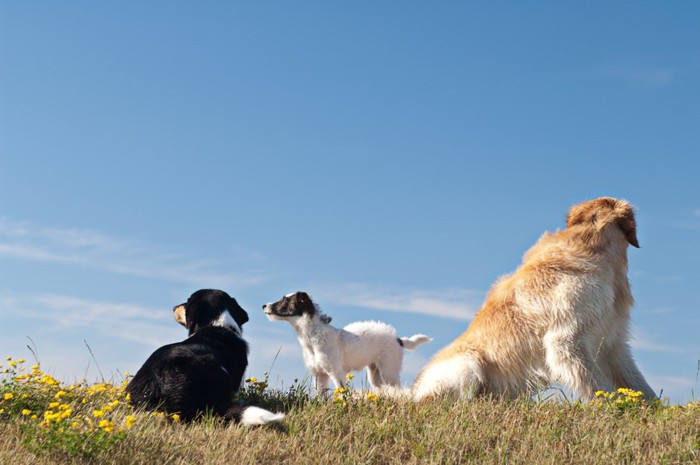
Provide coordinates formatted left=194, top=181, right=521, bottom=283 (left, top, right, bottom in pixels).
left=312, top=283, right=480, bottom=320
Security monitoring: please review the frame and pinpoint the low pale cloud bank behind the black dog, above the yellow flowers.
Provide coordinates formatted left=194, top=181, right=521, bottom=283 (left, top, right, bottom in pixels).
left=0, top=291, right=305, bottom=380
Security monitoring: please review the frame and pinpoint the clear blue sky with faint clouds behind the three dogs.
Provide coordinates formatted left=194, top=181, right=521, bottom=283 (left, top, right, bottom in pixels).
left=0, top=1, right=700, bottom=402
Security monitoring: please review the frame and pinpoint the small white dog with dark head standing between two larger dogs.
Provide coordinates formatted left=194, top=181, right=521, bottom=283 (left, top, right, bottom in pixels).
left=263, top=292, right=432, bottom=395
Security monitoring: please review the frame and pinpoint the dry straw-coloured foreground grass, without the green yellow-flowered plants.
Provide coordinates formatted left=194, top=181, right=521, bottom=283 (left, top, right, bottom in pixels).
left=0, top=399, right=700, bottom=464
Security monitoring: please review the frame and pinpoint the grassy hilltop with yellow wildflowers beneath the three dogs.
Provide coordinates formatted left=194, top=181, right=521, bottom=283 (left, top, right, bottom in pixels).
left=0, top=361, right=700, bottom=465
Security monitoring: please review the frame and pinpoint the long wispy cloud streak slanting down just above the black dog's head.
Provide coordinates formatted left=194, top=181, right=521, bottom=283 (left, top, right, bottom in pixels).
left=0, top=218, right=265, bottom=289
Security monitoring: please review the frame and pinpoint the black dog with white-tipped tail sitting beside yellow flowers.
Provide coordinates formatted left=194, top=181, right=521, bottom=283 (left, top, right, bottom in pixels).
left=126, top=289, right=284, bottom=425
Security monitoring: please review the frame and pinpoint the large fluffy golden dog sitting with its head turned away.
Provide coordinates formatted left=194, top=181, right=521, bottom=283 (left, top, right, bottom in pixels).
left=411, top=197, right=657, bottom=400
